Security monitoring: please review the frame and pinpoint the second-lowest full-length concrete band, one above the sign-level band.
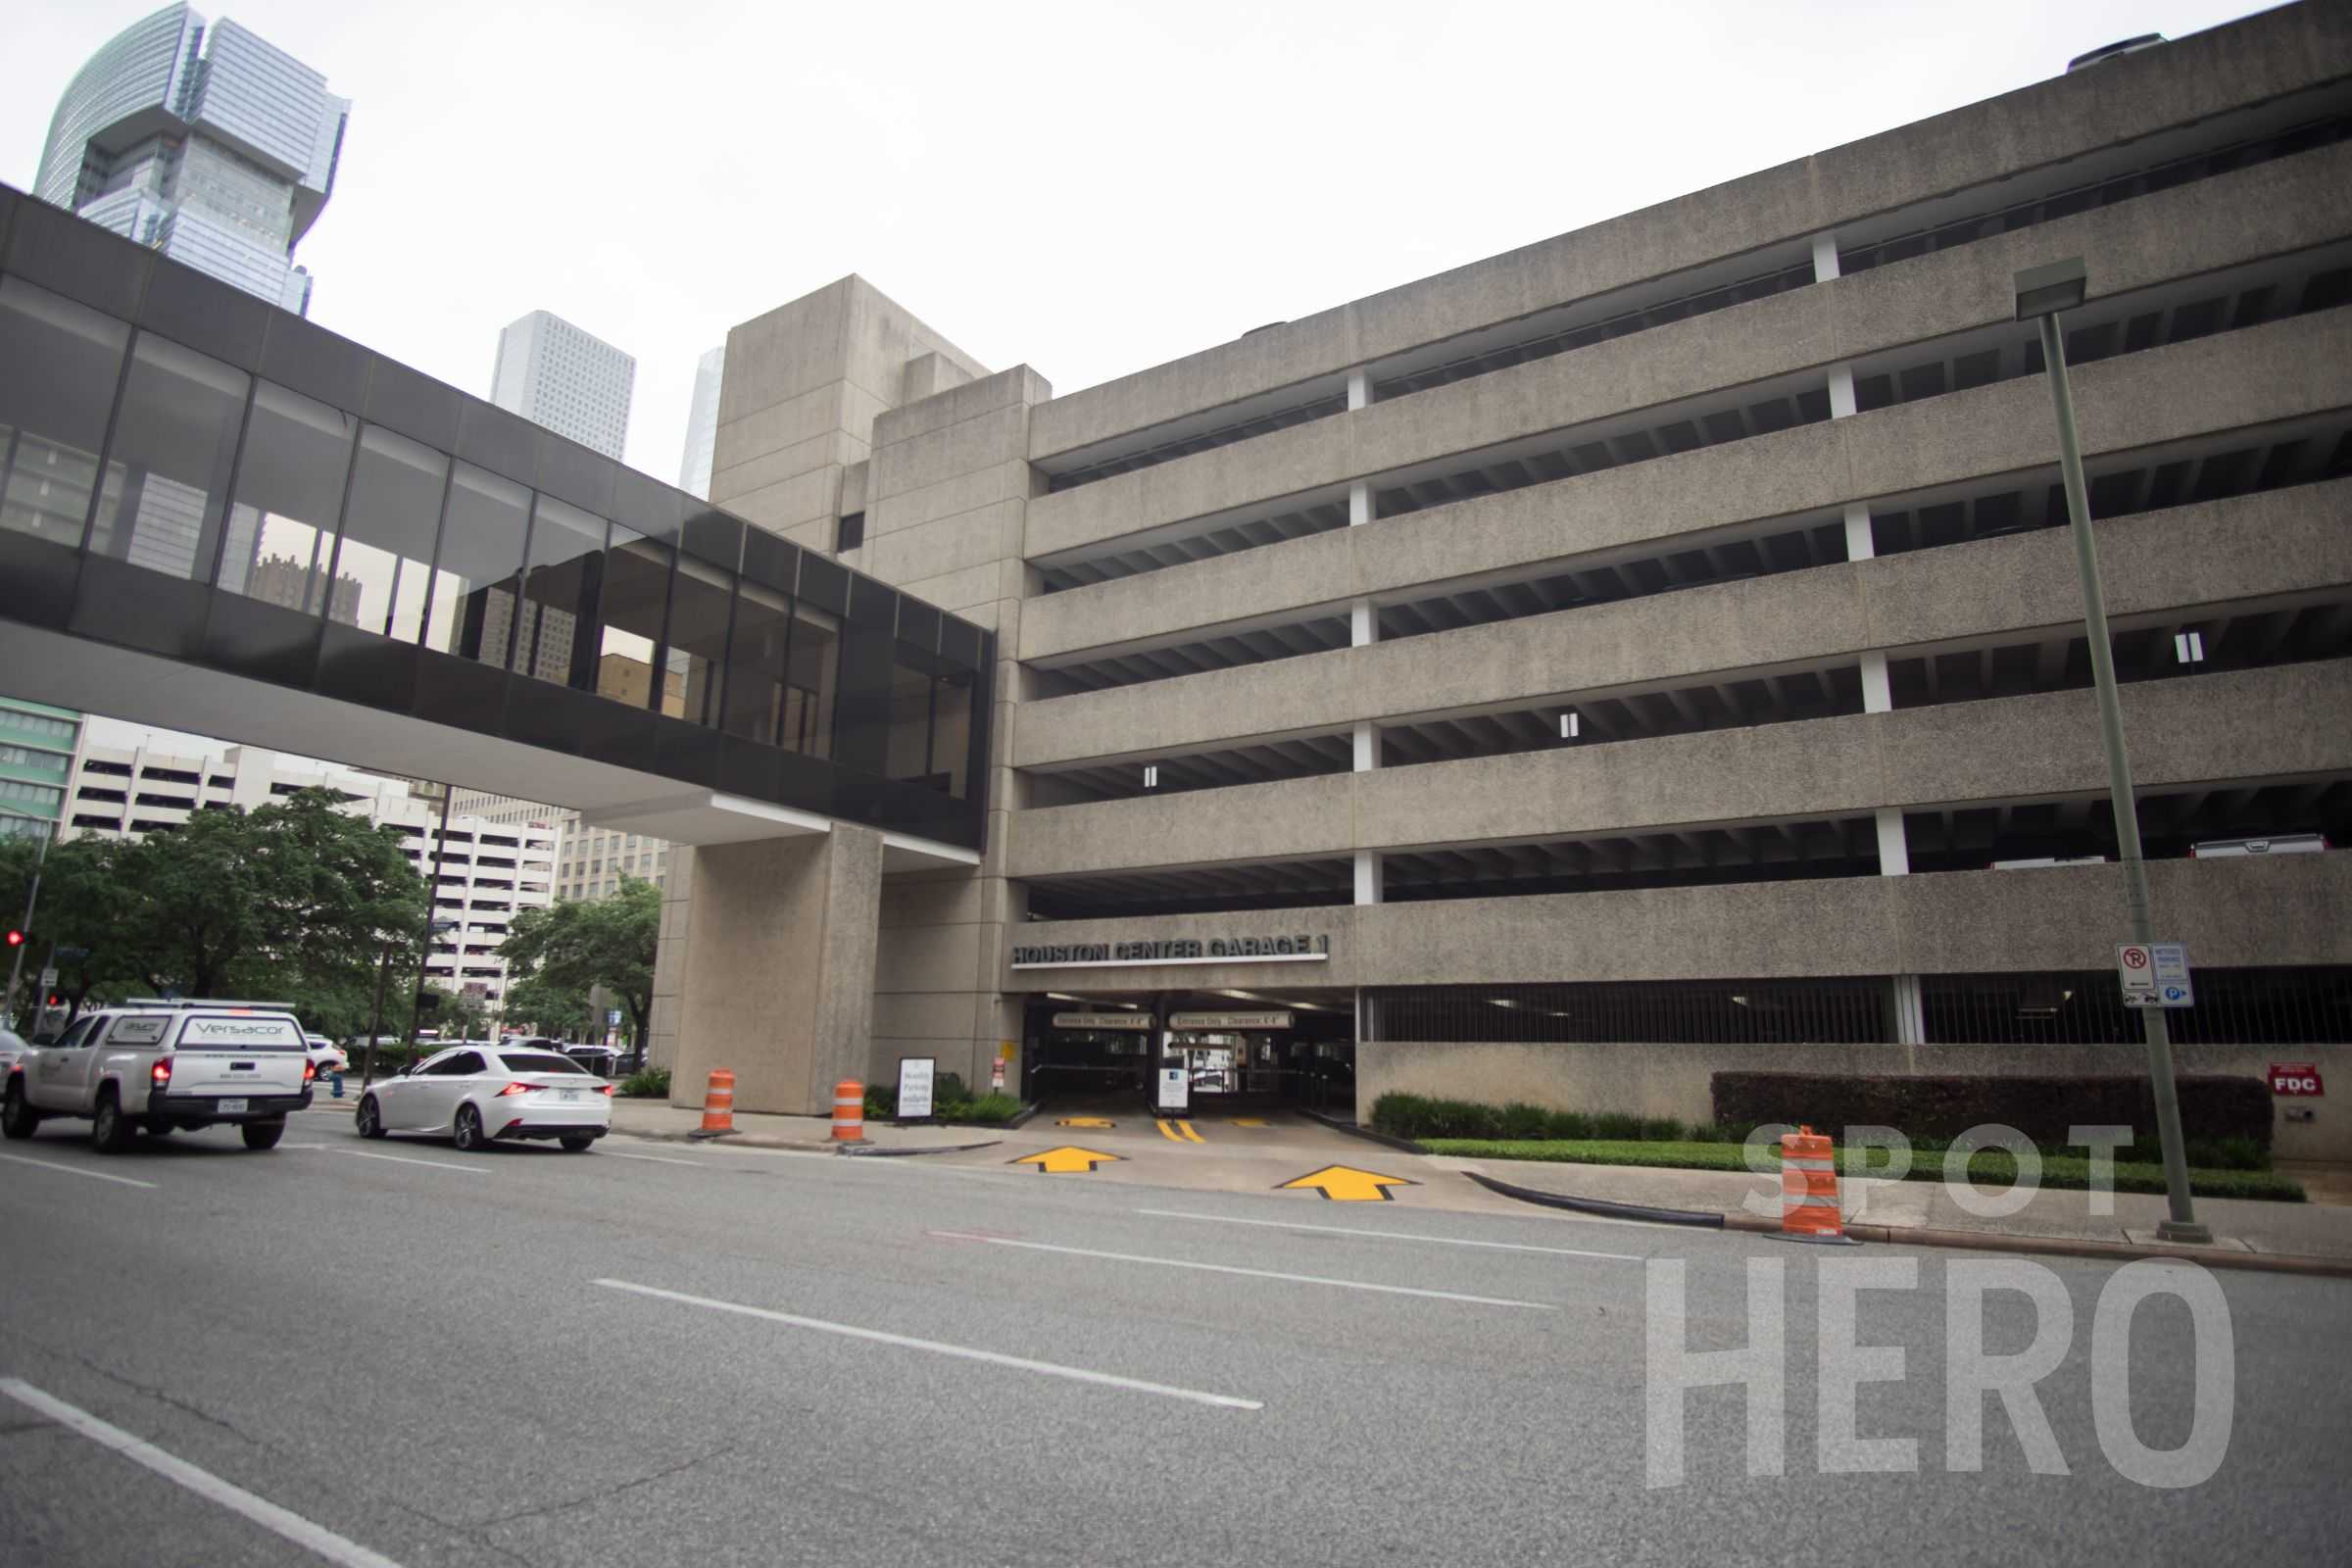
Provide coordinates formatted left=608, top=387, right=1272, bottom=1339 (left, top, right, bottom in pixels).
left=1006, top=661, right=2352, bottom=877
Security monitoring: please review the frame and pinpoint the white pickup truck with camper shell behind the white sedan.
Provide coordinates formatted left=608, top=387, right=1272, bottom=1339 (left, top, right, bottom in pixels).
left=0, top=1002, right=318, bottom=1154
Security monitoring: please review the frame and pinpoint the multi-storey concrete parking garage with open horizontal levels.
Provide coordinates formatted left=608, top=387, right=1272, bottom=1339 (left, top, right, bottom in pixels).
left=657, top=5, right=2352, bottom=1156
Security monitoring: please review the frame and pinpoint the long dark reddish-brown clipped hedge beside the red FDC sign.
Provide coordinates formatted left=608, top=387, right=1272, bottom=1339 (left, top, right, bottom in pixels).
left=1712, top=1072, right=2272, bottom=1163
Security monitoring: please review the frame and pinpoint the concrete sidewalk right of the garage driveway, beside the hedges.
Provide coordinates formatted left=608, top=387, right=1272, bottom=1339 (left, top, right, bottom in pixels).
left=1430, top=1154, right=2352, bottom=1274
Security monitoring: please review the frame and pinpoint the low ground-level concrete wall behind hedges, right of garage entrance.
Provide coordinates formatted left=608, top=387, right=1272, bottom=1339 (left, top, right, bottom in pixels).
left=1354, top=1039, right=2352, bottom=1159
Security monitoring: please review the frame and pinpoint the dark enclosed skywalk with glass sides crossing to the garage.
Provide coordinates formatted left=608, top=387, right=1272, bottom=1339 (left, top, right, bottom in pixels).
left=0, top=186, right=995, bottom=849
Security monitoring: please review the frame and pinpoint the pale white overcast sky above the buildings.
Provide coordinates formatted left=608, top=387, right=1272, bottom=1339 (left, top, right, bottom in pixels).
left=0, top=0, right=2263, bottom=761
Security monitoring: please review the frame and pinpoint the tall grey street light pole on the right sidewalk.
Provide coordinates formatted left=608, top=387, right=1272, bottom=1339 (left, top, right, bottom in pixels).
left=2016, top=259, right=2213, bottom=1242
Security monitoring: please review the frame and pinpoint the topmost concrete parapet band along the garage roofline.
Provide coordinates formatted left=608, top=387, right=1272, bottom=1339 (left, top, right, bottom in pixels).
left=1030, top=5, right=2352, bottom=459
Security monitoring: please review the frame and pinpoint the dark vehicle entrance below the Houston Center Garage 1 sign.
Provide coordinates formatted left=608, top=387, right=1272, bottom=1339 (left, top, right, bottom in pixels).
left=1023, top=990, right=1354, bottom=1114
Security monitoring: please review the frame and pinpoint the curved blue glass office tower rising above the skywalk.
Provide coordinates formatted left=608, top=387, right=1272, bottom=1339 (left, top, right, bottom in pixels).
left=33, top=5, right=351, bottom=315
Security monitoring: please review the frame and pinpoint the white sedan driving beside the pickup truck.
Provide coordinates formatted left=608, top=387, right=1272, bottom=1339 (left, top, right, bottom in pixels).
left=358, top=1044, right=612, bottom=1154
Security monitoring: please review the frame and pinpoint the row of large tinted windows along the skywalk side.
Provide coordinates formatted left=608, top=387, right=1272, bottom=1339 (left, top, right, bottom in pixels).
left=0, top=277, right=978, bottom=832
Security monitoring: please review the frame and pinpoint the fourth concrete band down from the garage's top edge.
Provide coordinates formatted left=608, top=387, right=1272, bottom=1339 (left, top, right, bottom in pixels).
left=1013, top=479, right=2352, bottom=768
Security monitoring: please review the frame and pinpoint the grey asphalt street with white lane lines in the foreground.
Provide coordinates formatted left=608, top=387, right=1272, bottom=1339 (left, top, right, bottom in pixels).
left=0, top=1112, right=2352, bottom=1568
